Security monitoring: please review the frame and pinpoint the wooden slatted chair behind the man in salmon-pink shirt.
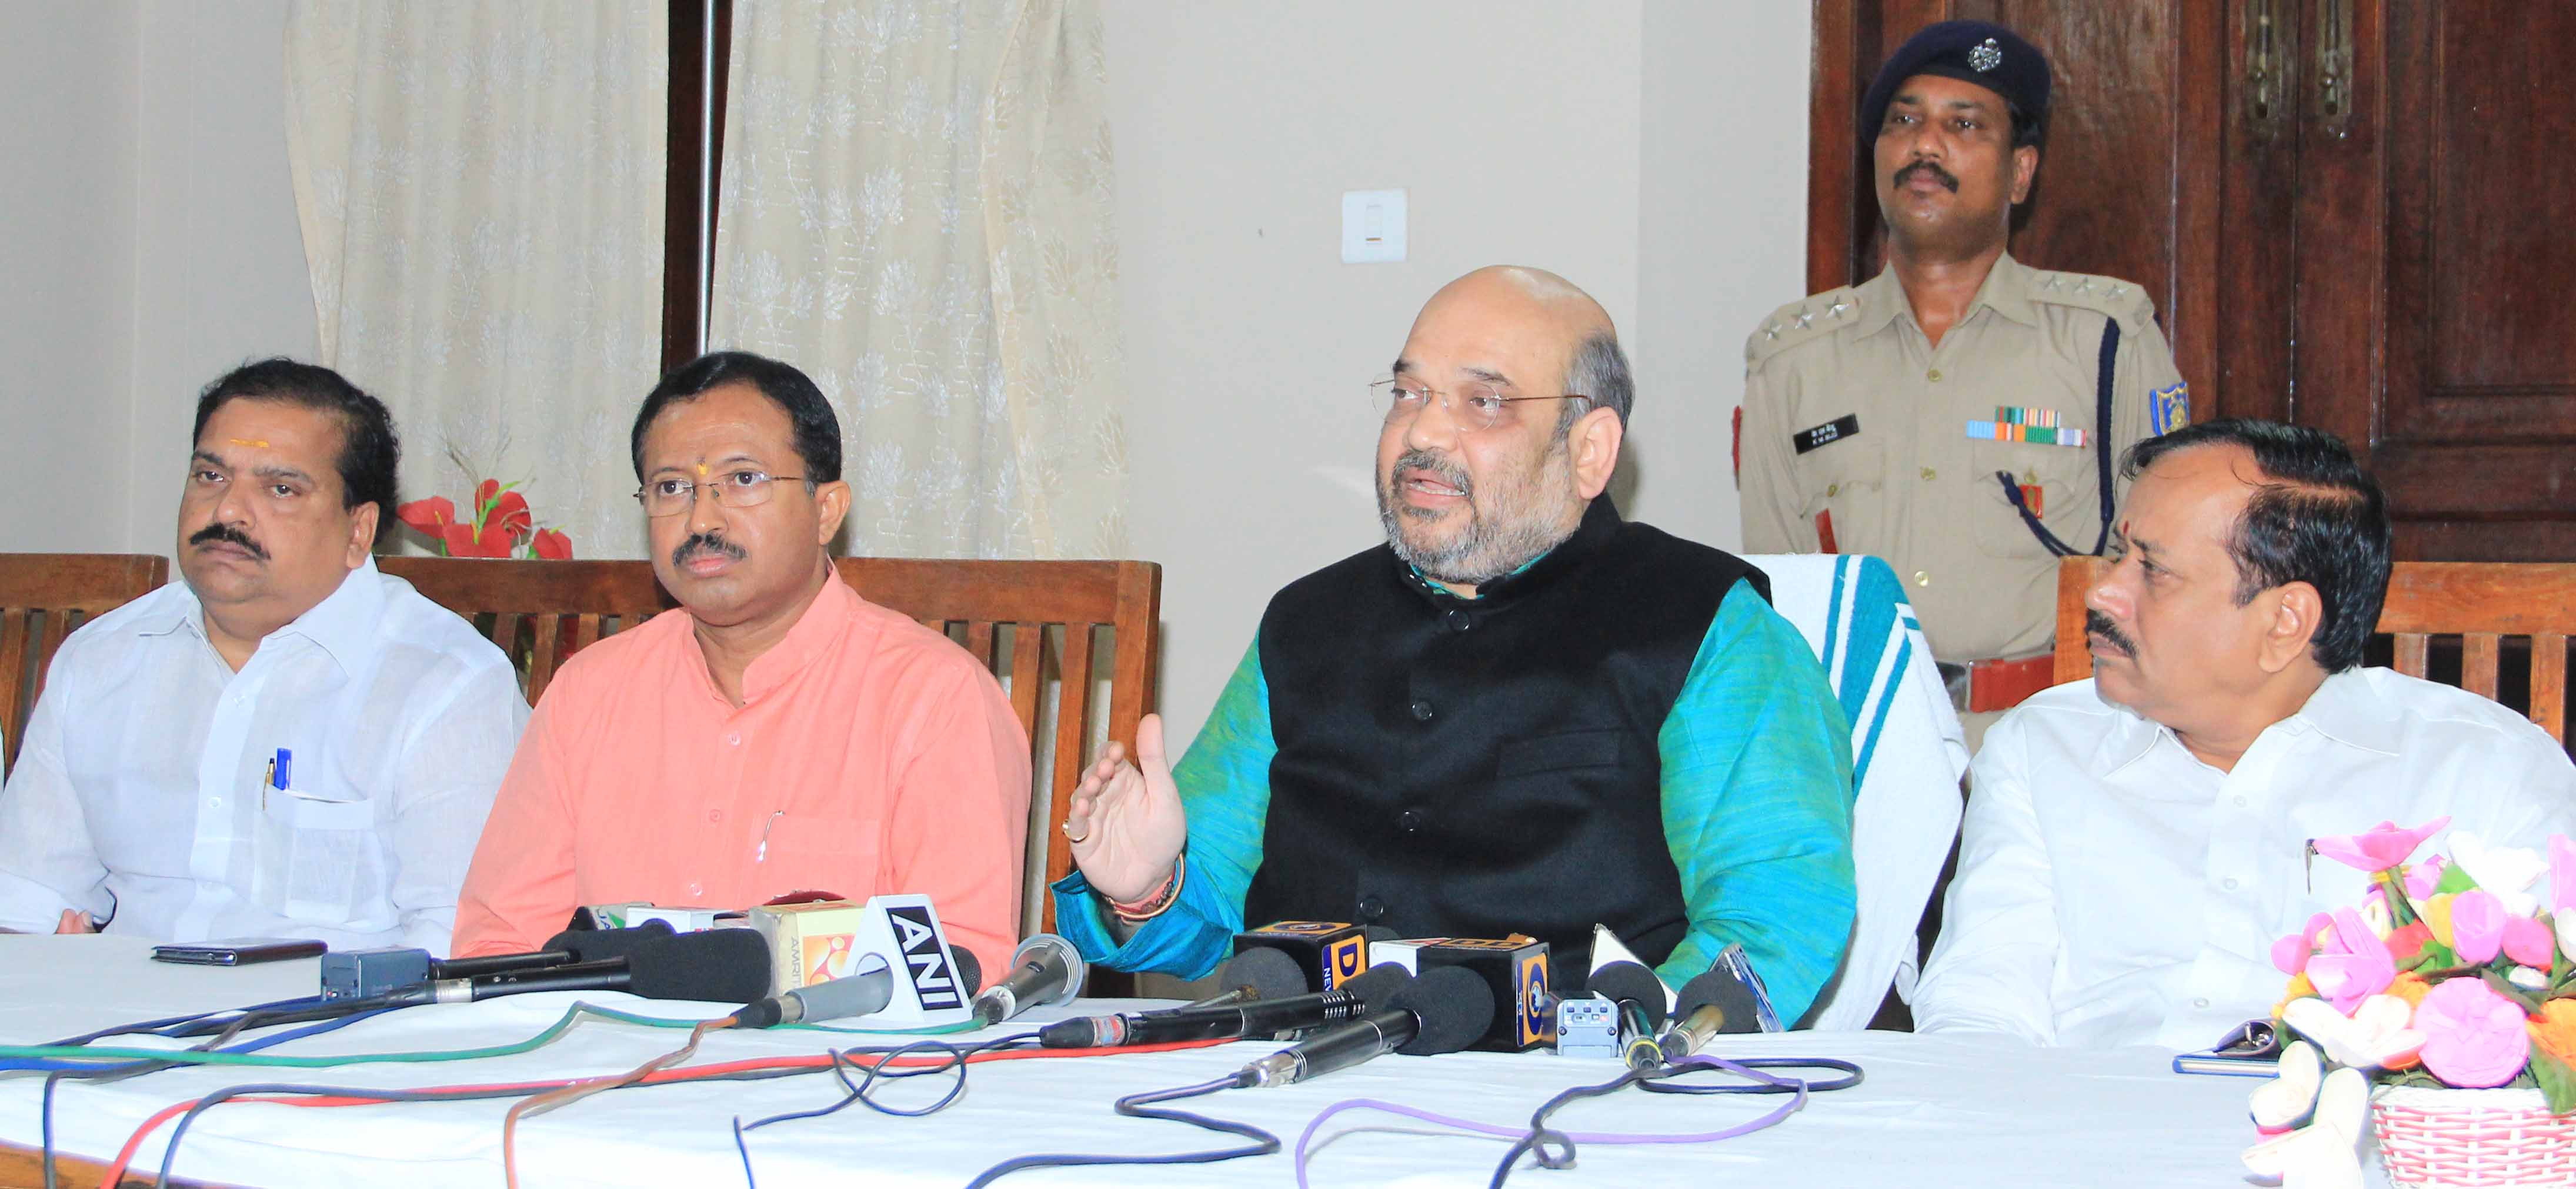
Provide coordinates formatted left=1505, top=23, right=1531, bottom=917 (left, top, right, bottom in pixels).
left=376, top=559, right=1162, bottom=929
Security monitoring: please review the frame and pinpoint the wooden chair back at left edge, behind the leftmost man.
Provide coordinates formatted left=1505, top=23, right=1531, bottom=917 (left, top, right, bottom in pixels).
left=0, top=553, right=170, bottom=774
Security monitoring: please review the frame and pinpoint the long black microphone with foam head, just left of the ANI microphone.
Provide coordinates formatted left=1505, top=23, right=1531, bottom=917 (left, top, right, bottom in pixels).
left=376, top=929, right=770, bottom=1009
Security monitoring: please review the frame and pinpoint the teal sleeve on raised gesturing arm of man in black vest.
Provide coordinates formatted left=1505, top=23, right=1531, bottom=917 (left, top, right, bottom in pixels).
left=1053, top=641, right=1277, bottom=978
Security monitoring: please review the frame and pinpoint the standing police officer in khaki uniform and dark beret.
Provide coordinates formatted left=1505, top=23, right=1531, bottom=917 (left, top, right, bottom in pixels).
left=1736, top=21, right=2190, bottom=746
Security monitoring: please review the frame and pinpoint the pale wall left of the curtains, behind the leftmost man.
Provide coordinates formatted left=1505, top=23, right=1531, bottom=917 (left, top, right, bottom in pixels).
left=0, top=0, right=317, bottom=553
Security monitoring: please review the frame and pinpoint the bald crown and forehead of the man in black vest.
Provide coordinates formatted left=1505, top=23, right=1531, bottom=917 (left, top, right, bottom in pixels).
left=1394, top=265, right=1633, bottom=425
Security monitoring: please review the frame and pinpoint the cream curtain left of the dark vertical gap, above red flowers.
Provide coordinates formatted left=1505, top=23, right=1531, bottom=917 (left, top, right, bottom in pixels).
left=286, top=0, right=670, bottom=556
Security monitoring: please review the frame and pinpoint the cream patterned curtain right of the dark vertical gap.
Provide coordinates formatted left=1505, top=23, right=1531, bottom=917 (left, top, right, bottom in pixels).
left=711, top=0, right=1126, bottom=559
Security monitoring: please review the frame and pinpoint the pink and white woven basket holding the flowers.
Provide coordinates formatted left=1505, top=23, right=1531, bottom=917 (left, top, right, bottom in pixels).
left=2370, top=1086, right=2576, bottom=1189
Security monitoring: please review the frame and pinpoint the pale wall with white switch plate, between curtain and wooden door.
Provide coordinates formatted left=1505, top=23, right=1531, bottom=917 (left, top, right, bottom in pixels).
left=1105, top=0, right=1808, bottom=746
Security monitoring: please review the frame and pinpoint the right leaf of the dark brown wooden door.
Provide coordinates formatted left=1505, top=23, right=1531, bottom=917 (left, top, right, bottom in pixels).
left=2290, top=0, right=2576, bottom=561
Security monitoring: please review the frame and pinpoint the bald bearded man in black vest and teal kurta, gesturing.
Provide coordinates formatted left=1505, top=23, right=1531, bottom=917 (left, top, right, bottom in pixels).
left=1056, top=268, right=1855, bottom=1019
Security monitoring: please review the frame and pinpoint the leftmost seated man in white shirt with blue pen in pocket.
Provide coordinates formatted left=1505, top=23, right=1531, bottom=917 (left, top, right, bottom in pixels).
left=0, top=360, right=528, bottom=955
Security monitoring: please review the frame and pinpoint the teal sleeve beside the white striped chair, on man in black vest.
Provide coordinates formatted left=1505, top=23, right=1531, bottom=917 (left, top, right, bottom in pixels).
left=1656, top=582, right=1857, bottom=1022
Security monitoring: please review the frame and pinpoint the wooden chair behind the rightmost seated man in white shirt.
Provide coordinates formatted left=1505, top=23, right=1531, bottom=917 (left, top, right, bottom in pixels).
left=2056, top=559, right=2576, bottom=746
